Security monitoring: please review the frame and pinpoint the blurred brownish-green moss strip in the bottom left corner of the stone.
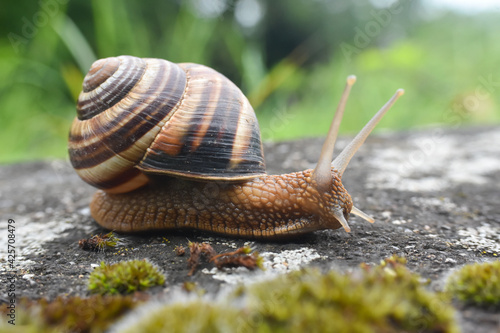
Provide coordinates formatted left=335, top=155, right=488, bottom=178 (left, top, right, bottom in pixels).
left=0, top=295, right=138, bottom=333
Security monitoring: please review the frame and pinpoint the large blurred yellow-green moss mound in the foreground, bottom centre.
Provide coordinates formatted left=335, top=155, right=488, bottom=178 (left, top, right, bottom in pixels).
left=118, top=257, right=458, bottom=333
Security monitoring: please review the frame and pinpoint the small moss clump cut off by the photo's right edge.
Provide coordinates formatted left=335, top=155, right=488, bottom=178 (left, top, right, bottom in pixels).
left=445, top=261, right=500, bottom=309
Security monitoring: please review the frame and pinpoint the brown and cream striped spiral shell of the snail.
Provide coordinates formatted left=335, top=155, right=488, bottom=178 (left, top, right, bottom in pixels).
left=69, top=56, right=266, bottom=193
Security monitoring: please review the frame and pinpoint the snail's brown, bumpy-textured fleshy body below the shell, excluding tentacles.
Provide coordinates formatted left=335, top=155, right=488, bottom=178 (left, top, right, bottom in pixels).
left=90, top=170, right=352, bottom=238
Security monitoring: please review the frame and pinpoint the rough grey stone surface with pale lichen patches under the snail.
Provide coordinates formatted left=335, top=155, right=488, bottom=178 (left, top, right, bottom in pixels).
left=0, top=127, right=500, bottom=333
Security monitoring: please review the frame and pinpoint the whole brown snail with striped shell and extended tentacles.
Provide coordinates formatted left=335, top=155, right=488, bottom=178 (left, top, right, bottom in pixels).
left=69, top=56, right=404, bottom=238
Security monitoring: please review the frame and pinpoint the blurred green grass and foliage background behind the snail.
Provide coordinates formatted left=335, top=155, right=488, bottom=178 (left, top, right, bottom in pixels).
left=0, top=0, right=500, bottom=163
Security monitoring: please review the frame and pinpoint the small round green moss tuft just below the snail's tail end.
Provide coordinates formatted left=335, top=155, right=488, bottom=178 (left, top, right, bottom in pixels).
left=88, top=260, right=165, bottom=295
